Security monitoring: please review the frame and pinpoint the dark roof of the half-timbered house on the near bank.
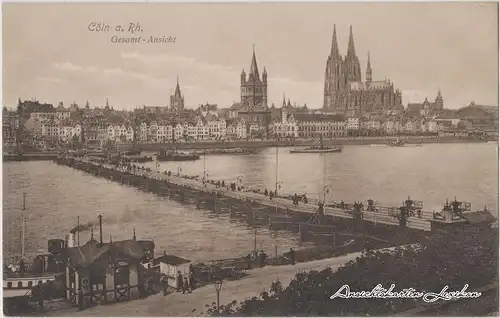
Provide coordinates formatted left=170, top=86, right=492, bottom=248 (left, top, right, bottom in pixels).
left=68, top=240, right=154, bottom=268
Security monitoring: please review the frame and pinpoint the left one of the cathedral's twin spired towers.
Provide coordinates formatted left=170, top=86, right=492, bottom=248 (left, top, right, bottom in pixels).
left=323, top=25, right=346, bottom=110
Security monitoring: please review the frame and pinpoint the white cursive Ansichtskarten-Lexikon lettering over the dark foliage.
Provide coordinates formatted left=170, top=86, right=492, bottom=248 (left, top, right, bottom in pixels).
left=330, top=284, right=481, bottom=303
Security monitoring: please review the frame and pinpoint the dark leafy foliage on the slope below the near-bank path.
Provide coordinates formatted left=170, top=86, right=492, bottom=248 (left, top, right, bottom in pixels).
left=203, top=226, right=498, bottom=316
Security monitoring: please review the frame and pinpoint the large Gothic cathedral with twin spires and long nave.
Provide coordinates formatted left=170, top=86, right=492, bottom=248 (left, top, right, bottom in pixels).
left=323, top=26, right=403, bottom=115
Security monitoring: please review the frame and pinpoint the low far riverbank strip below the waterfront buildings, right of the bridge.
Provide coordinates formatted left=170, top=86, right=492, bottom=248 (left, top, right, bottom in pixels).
left=117, top=136, right=492, bottom=151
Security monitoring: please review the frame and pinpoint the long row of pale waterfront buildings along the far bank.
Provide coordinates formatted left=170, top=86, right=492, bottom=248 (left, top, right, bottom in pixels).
left=10, top=105, right=492, bottom=144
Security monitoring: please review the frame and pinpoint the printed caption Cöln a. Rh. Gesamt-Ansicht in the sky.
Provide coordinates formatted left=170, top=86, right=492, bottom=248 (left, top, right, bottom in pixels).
left=87, top=21, right=177, bottom=44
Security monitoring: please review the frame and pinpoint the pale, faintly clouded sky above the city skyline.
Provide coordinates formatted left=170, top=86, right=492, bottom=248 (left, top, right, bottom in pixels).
left=2, top=2, right=499, bottom=109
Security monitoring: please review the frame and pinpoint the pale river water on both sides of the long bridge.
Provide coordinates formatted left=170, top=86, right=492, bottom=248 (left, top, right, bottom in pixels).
left=3, top=143, right=498, bottom=261
